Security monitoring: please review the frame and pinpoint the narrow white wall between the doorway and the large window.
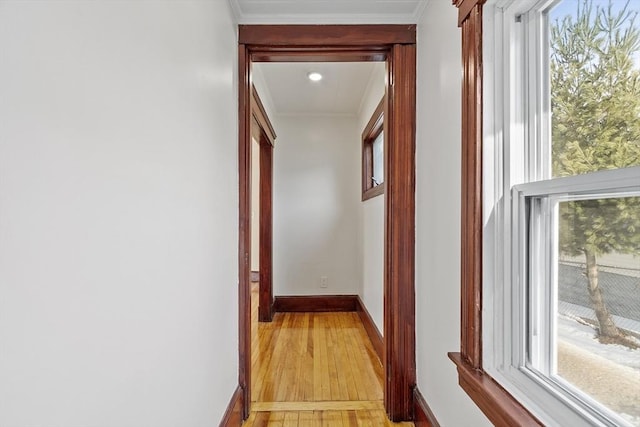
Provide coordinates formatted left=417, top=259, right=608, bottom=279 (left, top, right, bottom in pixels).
left=416, top=0, right=491, bottom=427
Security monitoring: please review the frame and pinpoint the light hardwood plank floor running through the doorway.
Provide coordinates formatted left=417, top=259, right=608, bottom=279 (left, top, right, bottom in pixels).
left=244, top=284, right=413, bottom=427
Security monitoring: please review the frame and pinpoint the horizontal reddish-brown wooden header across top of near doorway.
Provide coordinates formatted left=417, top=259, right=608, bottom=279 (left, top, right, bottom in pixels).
left=238, top=24, right=416, bottom=46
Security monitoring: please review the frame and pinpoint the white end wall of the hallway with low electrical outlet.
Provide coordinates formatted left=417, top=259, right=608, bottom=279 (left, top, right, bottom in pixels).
left=273, top=115, right=361, bottom=295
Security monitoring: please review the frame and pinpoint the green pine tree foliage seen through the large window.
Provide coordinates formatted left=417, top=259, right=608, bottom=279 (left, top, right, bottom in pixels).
left=550, top=0, right=640, bottom=255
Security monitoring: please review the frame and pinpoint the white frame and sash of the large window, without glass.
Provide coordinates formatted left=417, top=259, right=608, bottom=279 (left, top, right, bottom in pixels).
left=482, top=0, right=640, bottom=426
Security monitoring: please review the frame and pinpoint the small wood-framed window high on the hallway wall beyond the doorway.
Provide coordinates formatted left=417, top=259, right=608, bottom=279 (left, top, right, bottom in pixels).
left=362, top=98, right=384, bottom=201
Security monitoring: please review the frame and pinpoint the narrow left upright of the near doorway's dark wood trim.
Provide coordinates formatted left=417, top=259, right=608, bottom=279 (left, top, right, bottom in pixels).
left=238, top=44, right=251, bottom=420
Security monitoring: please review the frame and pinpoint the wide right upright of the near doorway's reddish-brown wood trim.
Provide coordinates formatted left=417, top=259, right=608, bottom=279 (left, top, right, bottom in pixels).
left=384, top=44, right=416, bottom=422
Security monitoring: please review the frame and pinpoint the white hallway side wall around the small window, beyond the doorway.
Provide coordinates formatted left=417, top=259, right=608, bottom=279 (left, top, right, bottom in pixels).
left=358, top=63, right=385, bottom=333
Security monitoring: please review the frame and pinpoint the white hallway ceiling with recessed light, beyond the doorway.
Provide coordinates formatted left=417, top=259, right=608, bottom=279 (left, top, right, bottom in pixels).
left=253, top=62, right=385, bottom=115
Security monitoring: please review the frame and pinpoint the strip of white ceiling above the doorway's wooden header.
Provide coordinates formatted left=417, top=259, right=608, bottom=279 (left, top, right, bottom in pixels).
left=228, top=0, right=429, bottom=24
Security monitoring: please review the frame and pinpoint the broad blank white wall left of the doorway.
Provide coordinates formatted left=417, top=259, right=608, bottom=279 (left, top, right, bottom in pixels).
left=0, top=0, right=238, bottom=427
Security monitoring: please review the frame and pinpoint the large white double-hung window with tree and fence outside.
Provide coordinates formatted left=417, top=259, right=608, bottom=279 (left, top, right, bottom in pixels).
left=483, top=0, right=640, bottom=426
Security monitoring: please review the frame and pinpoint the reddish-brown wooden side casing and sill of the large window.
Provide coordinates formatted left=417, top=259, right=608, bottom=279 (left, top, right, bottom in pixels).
left=449, top=0, right=542, bottom=427
